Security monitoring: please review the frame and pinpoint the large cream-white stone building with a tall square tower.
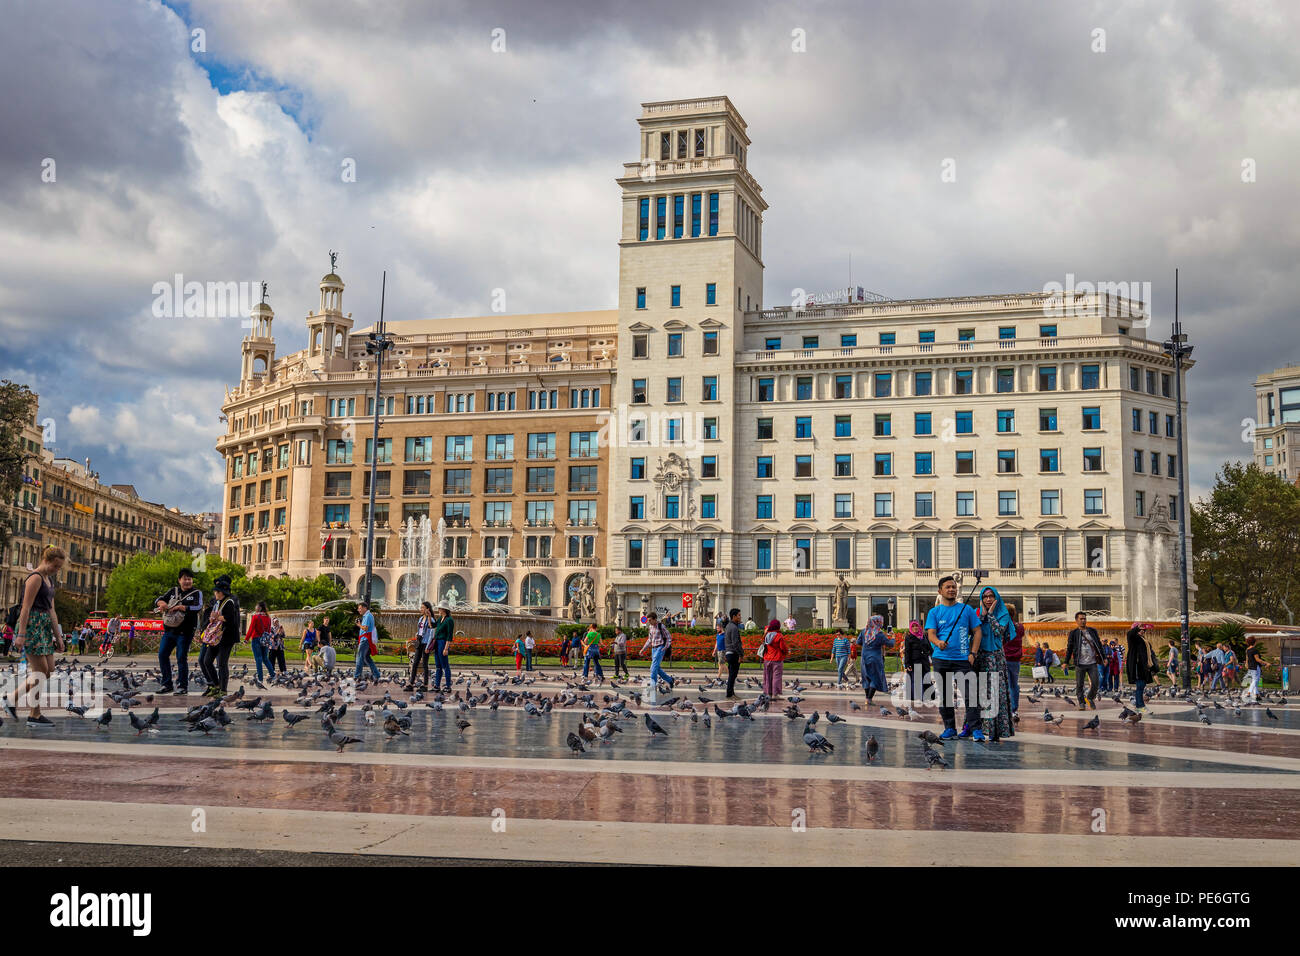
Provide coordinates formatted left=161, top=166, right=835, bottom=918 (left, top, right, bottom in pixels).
left=608, top=98, right=1182, bottom=626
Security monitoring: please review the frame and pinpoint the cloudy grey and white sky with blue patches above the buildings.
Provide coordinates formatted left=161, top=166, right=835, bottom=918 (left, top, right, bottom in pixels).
left=0, top=0, right=1300, bottom=510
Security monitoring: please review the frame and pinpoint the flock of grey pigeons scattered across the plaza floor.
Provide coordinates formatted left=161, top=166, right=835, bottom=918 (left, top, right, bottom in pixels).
left=0, top=659, right=1287, bottom=769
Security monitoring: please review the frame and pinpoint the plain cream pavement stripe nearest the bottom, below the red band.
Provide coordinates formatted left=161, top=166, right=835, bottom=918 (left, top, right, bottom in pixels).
left=0, top=800, right=1296, bottom=866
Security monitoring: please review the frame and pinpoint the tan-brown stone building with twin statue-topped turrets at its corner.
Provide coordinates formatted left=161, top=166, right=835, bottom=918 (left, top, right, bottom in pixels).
left=217, top=272, right=618, bottom=614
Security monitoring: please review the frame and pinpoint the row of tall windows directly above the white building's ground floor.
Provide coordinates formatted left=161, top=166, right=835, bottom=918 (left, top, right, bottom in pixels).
left=627, top=535, right=1133, bottom=571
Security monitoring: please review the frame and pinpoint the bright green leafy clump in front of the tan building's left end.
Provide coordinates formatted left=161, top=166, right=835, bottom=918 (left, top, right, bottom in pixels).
left=104, top=551, right=345, bottom=617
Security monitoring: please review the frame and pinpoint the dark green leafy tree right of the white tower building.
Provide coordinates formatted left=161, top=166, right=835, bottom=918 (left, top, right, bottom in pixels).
left=1191, top=462, right=1300, bottom=624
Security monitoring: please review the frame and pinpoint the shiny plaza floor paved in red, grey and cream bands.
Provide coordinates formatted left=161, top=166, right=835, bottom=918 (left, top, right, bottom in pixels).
left=0, top=657, right=1300, bottom=865
